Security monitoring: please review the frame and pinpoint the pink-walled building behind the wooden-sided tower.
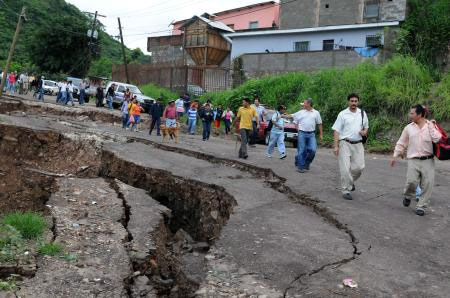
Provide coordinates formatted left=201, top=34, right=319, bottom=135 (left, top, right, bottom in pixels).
left=172, top=1, right=280, bottom=35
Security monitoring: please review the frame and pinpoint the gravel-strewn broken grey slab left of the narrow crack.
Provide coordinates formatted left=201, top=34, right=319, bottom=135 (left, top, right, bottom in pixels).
left=17, top=178, right=132, bottom=298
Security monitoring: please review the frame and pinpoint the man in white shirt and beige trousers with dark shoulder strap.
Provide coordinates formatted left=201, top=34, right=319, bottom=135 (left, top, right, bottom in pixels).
left=333, top=93, right=369, bottom=200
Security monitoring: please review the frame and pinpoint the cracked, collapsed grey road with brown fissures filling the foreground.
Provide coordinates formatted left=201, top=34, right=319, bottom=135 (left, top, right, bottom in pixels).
left=0, top=97, right=450, bottom=297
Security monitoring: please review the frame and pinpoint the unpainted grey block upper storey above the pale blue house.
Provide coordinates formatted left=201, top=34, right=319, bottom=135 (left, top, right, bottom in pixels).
left=280, top=0, right=407, bottom=29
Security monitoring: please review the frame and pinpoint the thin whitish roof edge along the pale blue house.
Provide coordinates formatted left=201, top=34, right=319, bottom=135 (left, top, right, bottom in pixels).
left=226, top=22, right=400, bottom=38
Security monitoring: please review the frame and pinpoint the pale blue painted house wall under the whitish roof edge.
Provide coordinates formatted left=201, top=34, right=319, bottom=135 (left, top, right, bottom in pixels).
left=231, top=28, right=383, bottom=59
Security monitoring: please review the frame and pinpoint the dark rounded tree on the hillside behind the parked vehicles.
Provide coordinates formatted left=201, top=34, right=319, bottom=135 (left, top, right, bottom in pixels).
left=29, top=16, right=95, bottom=77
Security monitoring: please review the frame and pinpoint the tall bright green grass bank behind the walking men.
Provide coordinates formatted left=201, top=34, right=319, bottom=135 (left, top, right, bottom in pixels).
left=201, top=55, right=450, bottom=152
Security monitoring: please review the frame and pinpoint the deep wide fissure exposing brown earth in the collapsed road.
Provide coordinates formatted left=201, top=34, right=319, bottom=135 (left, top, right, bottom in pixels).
left=0, top=124, right=236, bottom=297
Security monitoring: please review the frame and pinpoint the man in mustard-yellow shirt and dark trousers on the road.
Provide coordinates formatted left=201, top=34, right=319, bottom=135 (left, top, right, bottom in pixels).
left=236, top=98, right=259, bottom=159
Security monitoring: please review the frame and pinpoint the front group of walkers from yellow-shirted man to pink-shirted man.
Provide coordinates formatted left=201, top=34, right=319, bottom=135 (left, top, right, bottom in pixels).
left=237, top=93, right=442, bottom=216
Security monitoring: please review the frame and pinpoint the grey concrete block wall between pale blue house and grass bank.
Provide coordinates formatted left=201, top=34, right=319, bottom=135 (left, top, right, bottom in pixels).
left=239, top=50, right=383, bottom=79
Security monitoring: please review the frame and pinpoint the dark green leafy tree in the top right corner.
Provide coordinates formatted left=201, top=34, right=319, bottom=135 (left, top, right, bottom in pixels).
left=397, top=0, right=450, bottom=67
